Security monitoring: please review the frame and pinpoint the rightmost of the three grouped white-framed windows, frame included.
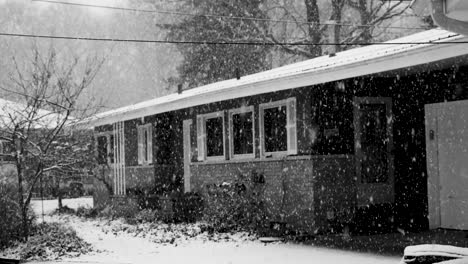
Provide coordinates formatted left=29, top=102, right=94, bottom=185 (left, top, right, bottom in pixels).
left=259, top=97, right=297, bottom=157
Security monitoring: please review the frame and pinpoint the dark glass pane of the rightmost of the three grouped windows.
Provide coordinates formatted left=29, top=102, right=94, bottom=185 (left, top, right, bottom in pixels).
left=263, top=105, right=288, bottom=152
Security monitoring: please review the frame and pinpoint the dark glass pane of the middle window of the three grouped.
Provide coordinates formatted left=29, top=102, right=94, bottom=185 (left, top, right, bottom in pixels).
left=232, top=112, right=253, bottom=155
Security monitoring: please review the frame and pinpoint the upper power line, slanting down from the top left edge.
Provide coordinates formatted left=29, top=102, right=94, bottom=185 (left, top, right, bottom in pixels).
left=31, top=0, right=427, bottom=30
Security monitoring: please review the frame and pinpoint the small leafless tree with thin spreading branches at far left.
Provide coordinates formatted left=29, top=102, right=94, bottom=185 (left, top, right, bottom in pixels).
left=0, top=47, right=103, bottom=239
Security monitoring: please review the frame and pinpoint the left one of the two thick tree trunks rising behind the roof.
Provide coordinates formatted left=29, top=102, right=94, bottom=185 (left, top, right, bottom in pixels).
left=305, top=0, right=322, bottom=57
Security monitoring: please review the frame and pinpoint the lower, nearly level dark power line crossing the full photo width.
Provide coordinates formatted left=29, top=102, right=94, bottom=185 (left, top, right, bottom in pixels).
left=0, top=32, right=468, bottom=46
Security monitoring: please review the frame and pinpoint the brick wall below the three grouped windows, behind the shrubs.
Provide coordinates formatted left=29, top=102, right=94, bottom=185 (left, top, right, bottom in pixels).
left=191, top=156, right=355, bottom=233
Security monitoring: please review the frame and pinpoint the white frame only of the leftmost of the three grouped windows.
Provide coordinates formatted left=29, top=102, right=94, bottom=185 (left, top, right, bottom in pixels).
left=197, top=111, right=226, bottom=161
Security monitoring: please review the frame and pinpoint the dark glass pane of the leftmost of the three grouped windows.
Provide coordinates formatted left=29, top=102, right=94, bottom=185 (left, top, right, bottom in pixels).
left=205, top=117, right=224, bottom=157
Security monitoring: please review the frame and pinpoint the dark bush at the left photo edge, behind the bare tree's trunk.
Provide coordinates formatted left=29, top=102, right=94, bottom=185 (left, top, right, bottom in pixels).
left=0, top=184, right=34, bottom=249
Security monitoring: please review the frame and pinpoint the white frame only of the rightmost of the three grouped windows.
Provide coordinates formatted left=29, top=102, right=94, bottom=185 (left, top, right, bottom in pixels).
left=259, top=97, right=297, bottom=158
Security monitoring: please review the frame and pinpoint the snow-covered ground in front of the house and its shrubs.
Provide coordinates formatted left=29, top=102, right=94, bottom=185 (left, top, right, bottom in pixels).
left=28, top=198, right=401, bottom=264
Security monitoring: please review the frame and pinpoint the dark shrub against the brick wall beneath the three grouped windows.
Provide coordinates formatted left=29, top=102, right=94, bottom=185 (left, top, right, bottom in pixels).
left=203, top=173, right=266, bottom=232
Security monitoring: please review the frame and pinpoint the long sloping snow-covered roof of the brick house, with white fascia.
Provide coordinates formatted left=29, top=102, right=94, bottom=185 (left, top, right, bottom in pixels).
left=87, top=29, right=468, bottom=126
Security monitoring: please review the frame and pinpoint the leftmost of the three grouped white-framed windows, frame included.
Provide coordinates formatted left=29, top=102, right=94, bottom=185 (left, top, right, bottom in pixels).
left=197, top=111, right=225, bottom=161
